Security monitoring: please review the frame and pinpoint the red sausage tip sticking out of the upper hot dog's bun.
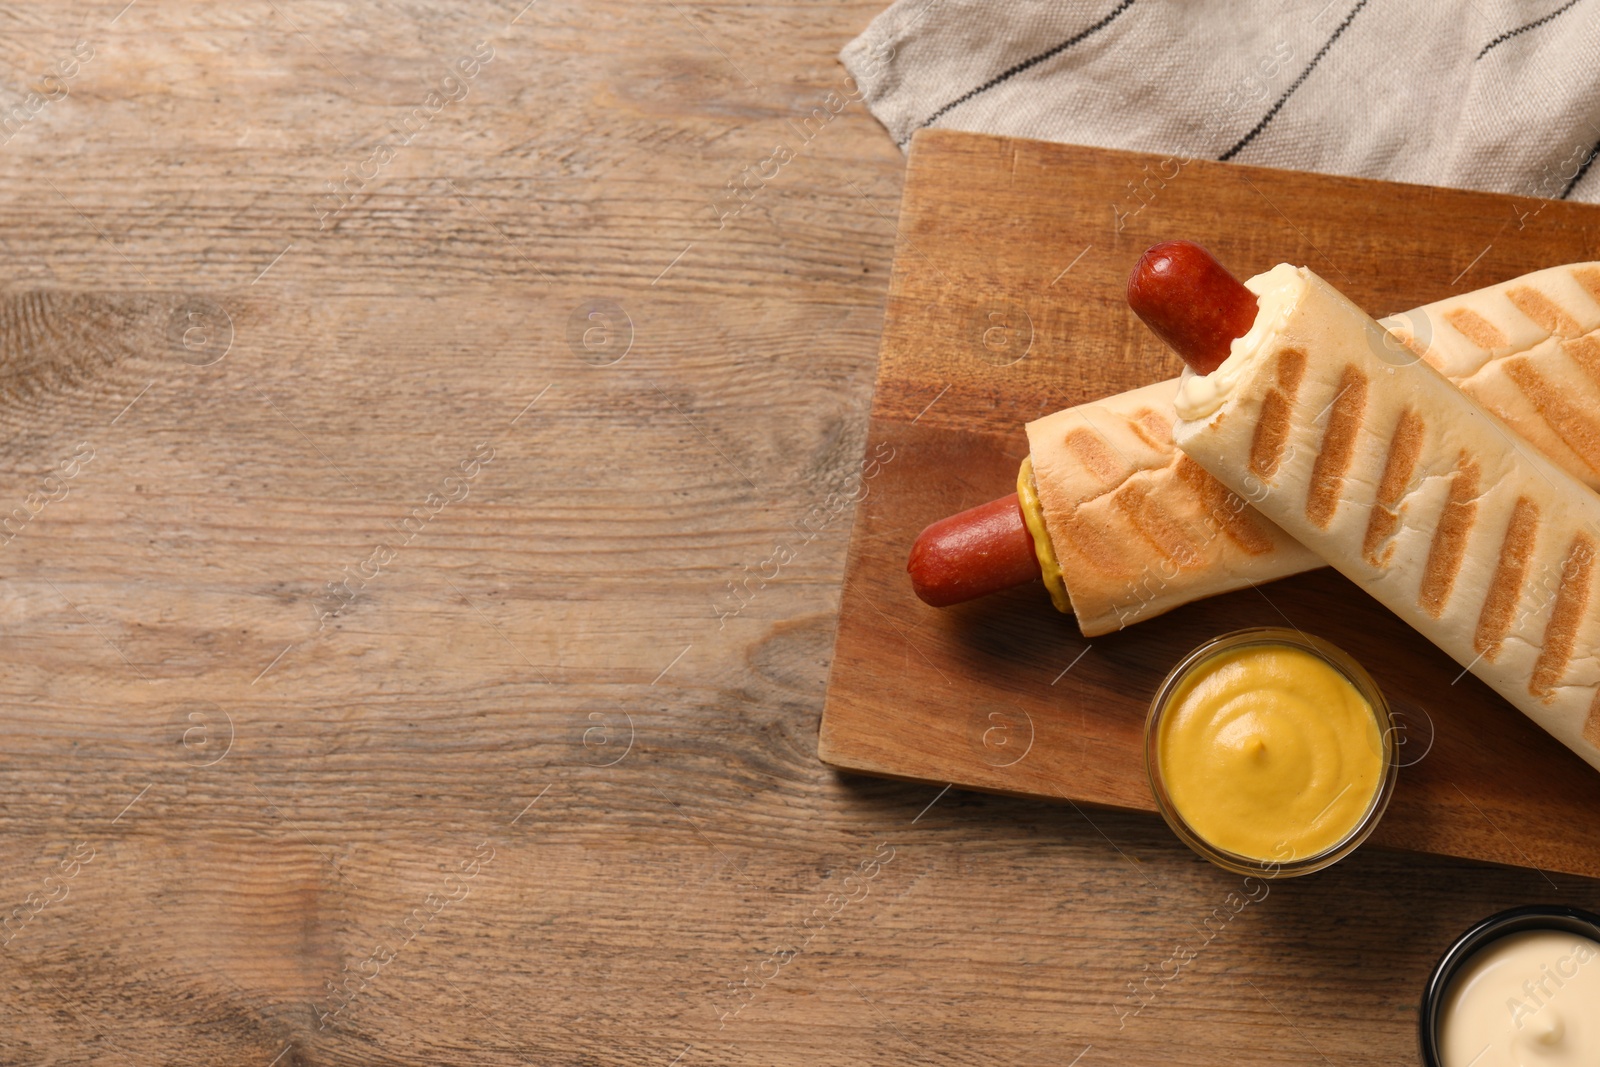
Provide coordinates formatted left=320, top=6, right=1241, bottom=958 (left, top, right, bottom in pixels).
left=1128, top=242, right=1256, bottom=374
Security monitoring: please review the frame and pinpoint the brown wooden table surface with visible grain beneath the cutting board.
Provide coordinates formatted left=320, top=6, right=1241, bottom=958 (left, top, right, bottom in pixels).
left=0, top=0, right=1600, bottom=1067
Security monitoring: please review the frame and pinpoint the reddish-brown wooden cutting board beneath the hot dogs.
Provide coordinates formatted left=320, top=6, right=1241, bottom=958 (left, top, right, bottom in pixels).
left=819, top=131, right=1600, bottom=877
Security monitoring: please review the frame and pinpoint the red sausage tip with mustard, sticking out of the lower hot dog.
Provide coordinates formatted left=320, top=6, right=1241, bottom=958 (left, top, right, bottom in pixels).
left=906, top=493, right=1040, bottom=608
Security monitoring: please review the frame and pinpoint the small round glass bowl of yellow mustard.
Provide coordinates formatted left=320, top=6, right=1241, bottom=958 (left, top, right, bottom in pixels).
left=1146, top=630, right=1394, bottom=875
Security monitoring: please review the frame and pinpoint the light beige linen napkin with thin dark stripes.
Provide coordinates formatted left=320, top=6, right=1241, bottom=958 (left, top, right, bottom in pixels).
left=840, top=0, right=1600, bottom=202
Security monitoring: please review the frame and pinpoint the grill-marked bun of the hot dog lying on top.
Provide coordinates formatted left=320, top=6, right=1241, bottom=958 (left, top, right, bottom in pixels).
left=1162, top=247, right=1600, bottom=768
